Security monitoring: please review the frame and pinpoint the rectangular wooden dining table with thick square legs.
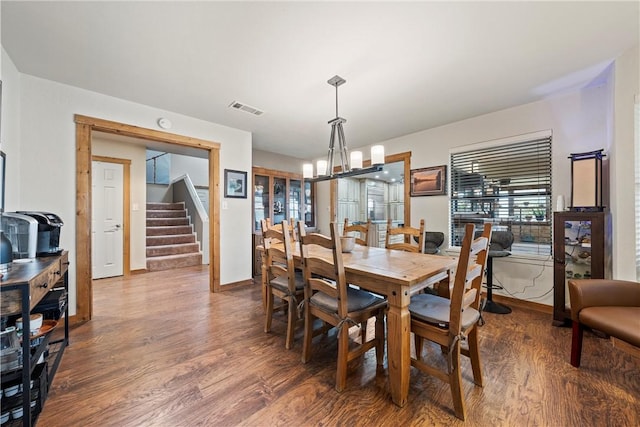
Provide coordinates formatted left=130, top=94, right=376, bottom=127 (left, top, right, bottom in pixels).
left=262, top=244, right=457, bottom=406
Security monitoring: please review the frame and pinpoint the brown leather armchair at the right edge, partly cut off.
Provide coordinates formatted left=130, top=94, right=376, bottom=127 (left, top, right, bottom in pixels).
left=569, top=279, right=640, bottom=368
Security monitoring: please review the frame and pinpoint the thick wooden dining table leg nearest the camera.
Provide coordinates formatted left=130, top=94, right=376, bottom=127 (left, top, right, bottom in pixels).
left=387, top=288, right=411, bottom=407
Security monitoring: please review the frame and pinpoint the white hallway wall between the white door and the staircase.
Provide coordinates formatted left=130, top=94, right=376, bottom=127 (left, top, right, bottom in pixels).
left=92, top=135, right=147, bottom=270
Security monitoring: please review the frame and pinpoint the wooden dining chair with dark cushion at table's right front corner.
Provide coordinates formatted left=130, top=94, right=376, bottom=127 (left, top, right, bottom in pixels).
left=409, top=224, right=491, bottom=420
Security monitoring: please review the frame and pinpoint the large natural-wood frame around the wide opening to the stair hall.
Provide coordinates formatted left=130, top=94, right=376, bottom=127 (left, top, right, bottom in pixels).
left=74, top=114, right=220, bottom=322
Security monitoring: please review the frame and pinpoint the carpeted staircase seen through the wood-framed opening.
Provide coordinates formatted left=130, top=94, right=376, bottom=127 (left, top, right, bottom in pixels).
left=147, top=202, right=202, bottom=271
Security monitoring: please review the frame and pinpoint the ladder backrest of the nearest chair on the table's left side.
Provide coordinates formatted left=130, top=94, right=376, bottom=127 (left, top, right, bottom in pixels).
left=298, top=221, right=348, bottom=319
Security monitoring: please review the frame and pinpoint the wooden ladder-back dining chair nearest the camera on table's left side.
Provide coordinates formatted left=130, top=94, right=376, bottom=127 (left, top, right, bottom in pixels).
left=298, top=222, right=387, bottom=392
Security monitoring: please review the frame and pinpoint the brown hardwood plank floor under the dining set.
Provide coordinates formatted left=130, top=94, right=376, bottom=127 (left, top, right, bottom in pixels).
left=38, top=267, right=640, bottom=427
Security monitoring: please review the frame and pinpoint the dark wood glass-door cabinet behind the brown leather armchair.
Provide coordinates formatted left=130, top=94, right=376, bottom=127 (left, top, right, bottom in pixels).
left=553, top=212, right=612, bottom=326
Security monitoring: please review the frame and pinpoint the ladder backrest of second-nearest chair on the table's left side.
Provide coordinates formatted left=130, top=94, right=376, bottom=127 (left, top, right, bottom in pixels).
left=260, top=219, right=296, bottom=293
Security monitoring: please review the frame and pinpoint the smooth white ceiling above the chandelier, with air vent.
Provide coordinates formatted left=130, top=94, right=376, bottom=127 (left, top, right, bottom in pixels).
left=0, top=0, right=640, bottom=158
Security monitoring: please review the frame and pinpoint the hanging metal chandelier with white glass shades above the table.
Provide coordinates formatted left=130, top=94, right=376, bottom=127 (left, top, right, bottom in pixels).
left=302, top=76, right=384, bottom=182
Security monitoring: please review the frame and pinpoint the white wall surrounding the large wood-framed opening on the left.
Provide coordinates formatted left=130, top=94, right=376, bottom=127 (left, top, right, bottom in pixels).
left=2, top=50, right=252, bottom=314
